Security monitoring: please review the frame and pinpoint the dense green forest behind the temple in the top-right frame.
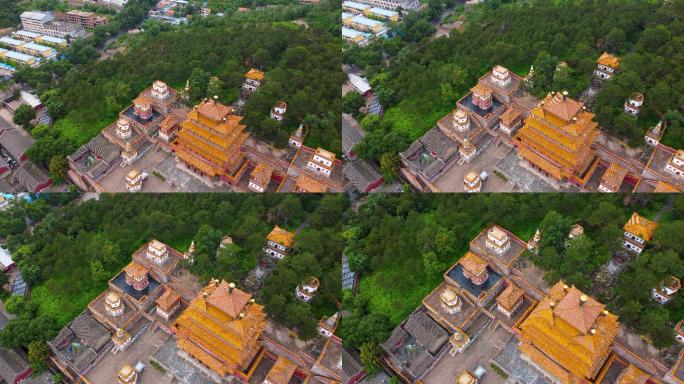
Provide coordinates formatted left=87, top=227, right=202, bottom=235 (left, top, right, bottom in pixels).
left=343, top=0, right=684, bottom=160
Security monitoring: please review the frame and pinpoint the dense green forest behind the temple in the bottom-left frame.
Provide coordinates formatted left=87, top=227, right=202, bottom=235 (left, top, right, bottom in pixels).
left=0, top=194, right=342, bottom=346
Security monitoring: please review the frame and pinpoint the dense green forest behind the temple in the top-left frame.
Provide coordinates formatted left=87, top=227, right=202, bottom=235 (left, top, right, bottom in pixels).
left=16, top=0, right=343, bottom=175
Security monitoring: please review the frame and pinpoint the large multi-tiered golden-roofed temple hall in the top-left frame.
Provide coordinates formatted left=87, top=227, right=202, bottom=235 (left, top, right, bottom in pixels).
left=173, top=98, right=247, bottom=184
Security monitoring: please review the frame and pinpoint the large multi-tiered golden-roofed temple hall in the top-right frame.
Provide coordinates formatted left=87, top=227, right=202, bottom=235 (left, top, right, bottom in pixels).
left=515, top=92, right=598, bottom=187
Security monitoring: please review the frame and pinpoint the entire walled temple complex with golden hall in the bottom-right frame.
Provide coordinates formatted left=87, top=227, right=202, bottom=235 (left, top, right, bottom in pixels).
left=381, top=225, right=668, bottom=384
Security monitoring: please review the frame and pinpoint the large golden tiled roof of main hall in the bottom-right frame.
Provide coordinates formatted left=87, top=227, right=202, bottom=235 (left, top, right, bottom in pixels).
left=518, top=281, right=620, bottom=383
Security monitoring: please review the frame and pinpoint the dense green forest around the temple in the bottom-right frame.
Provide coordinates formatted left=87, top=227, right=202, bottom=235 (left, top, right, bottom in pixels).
left=340, top=194, right=684, bottom=354
